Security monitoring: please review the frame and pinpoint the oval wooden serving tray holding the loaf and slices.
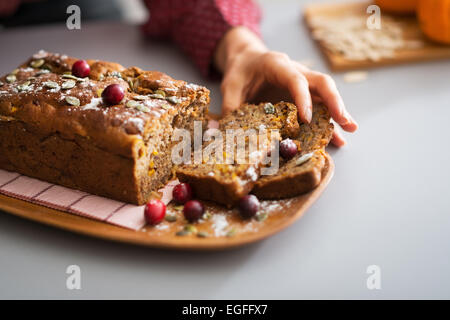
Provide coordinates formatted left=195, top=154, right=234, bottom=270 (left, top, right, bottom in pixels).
left=0, top=154, right=334, bottom=250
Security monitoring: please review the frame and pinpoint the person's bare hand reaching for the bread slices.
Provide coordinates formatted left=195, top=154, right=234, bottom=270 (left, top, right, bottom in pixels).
left=215, top=27, right=358, bottom=147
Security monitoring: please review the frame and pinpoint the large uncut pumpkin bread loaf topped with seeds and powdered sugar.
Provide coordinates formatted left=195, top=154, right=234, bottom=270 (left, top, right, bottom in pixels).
left=0, top=51, right=209, bottom=205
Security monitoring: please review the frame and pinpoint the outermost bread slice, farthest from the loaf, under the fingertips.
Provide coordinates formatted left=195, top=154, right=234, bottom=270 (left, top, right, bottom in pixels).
left=252, top=105, right=334, bottom=199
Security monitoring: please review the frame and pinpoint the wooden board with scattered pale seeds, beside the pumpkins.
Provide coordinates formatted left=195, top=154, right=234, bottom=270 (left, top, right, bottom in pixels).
left=304, top=2, right=450, bottom=71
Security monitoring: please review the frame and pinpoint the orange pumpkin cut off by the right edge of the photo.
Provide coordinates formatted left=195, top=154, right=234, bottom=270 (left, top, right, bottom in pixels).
left=417, top=0, right=450, bottom=44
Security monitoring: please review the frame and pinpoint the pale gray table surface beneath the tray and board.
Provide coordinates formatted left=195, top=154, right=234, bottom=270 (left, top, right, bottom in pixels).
left=0, top=1, right=450, bottom=299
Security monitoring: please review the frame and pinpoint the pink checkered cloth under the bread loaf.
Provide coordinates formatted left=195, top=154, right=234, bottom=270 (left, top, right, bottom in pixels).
left=0, top=169, right=178, bottom=230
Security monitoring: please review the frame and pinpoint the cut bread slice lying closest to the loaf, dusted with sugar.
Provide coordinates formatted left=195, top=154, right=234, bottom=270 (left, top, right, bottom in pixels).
left=176, top=102, right=300, bottom=207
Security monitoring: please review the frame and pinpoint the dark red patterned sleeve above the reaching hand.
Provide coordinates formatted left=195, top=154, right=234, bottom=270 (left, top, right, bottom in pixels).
left=142, top=0, right=261, bottom=75
